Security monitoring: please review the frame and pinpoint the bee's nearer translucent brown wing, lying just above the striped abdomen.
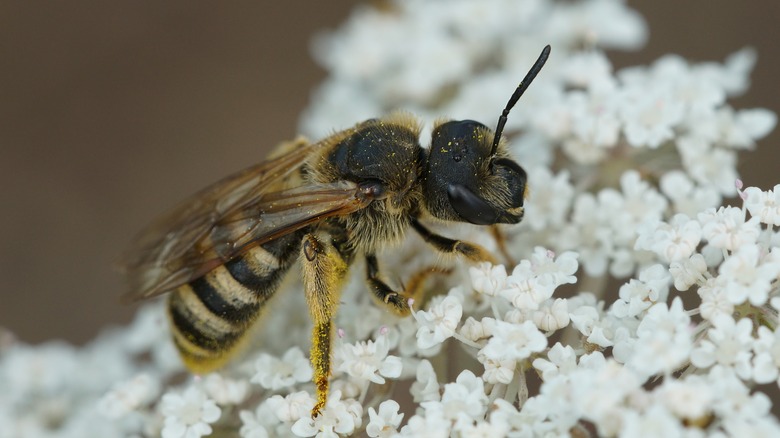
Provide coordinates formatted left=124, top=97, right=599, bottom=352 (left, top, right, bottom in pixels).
left=123, top=181, right=371, bottom=301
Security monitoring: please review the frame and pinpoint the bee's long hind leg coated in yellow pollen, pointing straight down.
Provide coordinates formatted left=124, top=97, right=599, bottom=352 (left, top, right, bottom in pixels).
left=301, top=234, right=348, bottom=418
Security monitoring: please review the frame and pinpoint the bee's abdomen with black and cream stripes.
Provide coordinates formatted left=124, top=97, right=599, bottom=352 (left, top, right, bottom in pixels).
left=168, top=233, right=301, bottom=373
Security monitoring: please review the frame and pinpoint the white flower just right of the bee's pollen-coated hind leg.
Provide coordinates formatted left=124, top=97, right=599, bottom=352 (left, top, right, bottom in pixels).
left=336, top=335, right=403, bottom=385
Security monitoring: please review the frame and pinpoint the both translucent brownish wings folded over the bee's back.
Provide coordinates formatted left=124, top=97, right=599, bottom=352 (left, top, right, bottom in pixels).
left=119, top=143, right=370, bottom=301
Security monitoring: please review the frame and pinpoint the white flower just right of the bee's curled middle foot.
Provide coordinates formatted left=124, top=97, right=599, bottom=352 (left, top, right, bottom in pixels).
left=413, top=296, right=463, bottom=349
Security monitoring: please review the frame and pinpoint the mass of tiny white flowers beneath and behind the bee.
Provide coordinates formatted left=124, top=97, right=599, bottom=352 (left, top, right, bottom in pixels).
left=0, top=0, right=780, bottom=438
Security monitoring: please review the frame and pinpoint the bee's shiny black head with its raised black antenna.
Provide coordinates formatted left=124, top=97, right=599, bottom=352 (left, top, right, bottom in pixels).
left=424, top=46, right=550, bottom=225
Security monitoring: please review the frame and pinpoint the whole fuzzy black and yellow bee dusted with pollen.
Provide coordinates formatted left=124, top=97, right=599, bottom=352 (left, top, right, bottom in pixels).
left=121, top=46, right=550, bottom=416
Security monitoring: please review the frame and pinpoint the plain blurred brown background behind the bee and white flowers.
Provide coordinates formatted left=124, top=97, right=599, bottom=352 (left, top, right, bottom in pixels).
left=0, top=0, right=780, bottom=342
